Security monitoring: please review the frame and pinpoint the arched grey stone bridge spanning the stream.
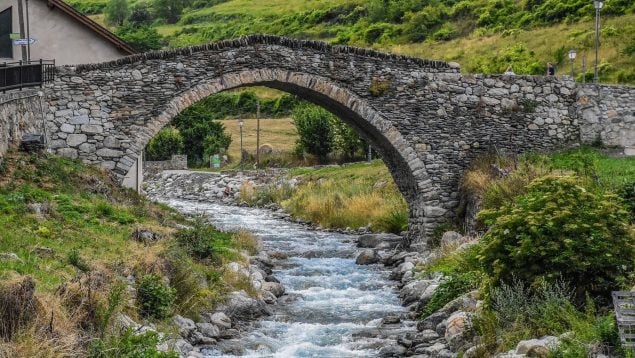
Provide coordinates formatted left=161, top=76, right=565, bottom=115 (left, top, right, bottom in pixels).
left=46, top=35, right=632, bottom=239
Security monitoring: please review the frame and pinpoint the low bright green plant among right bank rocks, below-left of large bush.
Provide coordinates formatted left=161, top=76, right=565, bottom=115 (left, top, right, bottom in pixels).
left=421, top=271, right=483, bottom=318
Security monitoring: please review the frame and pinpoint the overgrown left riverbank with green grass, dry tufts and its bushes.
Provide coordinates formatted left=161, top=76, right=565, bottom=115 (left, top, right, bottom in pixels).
left=0, top=153, right=256, bottom=357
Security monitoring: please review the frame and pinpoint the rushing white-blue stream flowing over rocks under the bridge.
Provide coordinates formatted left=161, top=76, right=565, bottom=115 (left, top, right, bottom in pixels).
left=167, top=200, right=414, bottom=358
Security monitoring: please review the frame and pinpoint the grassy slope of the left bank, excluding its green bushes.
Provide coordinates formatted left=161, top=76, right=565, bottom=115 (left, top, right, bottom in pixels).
left=0, top=153, right=254, bottom=356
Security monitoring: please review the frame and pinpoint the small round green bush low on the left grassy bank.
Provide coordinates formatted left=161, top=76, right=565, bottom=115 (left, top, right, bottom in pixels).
left=137, top=274, right=176, bottom=319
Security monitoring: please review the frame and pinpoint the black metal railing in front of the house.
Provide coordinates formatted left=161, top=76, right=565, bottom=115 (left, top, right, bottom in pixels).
left=0, top=60, right=55, bottom=92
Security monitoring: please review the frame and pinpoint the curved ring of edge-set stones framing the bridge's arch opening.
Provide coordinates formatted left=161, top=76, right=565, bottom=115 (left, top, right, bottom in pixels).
left=131, top=69, right=436, bottom=235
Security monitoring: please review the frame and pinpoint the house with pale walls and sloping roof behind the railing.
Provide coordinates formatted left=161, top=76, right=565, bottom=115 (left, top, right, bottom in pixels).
left=0, top=0, right=136, bottom=65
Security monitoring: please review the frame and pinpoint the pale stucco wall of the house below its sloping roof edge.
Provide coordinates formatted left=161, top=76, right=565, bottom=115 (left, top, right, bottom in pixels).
left=0, top=0, right=125, bottom=65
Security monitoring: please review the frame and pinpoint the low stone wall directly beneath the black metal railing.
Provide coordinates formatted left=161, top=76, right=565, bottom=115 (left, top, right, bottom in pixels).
left=0, top=90, right=46, bottom=158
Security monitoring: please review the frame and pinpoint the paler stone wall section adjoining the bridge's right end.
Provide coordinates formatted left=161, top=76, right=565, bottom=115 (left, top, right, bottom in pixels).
left=577, top=85, right=635, bottom=155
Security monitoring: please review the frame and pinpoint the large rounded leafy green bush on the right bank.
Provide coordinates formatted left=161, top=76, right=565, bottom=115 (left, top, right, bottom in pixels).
left=479, top=177, right=635, bottom=300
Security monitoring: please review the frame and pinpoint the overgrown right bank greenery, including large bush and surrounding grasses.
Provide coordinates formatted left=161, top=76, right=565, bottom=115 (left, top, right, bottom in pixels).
left=421, top=148, right=635, bottom=357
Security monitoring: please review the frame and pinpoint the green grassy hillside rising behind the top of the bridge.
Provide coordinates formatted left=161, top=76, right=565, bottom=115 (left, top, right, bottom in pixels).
left=71, top=0, right=635, bottom=83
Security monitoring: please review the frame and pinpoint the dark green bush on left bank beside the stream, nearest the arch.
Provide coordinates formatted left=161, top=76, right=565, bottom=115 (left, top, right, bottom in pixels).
left=175, top=217, right=231, bottom=259
